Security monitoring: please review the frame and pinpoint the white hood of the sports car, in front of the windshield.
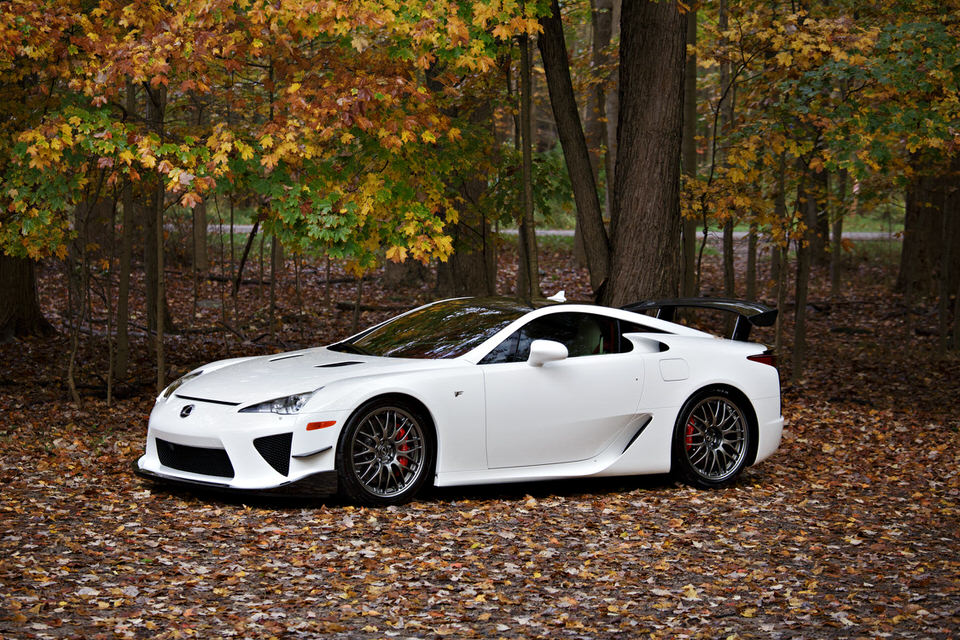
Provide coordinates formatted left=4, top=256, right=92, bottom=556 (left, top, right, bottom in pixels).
left=174, top=347, right=437, bottom=405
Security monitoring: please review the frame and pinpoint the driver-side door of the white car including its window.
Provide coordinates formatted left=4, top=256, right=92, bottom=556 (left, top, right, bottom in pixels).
left=480, top=312, right=643, bottom=468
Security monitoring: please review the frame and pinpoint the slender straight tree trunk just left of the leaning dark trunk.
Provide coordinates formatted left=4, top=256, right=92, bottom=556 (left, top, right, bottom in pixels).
left=517, top=35, right=540, bottom=298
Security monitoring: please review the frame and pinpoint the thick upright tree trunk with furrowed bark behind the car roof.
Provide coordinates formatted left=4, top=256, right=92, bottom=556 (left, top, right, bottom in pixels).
left=603, top=0, right=686, bottom=306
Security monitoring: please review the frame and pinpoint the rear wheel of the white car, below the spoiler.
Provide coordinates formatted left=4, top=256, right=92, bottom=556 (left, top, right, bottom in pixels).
left=673, top=388, right=752, bottom=489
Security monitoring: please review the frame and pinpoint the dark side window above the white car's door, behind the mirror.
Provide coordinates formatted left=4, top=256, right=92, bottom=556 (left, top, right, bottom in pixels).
left=480, top=313, right=629, bottom=364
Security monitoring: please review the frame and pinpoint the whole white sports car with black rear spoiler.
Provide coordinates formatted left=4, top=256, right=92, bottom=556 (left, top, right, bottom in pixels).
left=135, top=298, right=783, bottom=505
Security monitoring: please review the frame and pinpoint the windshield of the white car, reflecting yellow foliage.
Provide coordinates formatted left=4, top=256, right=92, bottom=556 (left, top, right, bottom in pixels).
left=330, top=298, right=533, bottom=358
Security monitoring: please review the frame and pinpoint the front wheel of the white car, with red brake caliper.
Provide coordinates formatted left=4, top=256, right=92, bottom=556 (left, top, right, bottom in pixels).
left=336, top=398, right=436, bottom=506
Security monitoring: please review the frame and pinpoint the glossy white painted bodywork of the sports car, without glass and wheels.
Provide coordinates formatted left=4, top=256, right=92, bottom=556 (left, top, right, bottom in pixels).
left=136, top=296, right=783, bottom=500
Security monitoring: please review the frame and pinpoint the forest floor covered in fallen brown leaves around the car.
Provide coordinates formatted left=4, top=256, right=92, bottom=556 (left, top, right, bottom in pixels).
left=0, top=238, right=960, bottom=639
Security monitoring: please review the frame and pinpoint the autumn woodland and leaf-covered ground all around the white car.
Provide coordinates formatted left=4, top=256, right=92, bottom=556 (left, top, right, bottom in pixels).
left=0, top=0, right=960, bottom=638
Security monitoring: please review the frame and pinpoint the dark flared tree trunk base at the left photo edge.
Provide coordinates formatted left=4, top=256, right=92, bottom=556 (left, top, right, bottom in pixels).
left=0, top=252, right=55, bottom=342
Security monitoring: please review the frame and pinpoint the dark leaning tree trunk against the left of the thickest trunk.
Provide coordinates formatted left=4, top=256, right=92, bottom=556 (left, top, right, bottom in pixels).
left=538, top=0, right=612, bottom=291
